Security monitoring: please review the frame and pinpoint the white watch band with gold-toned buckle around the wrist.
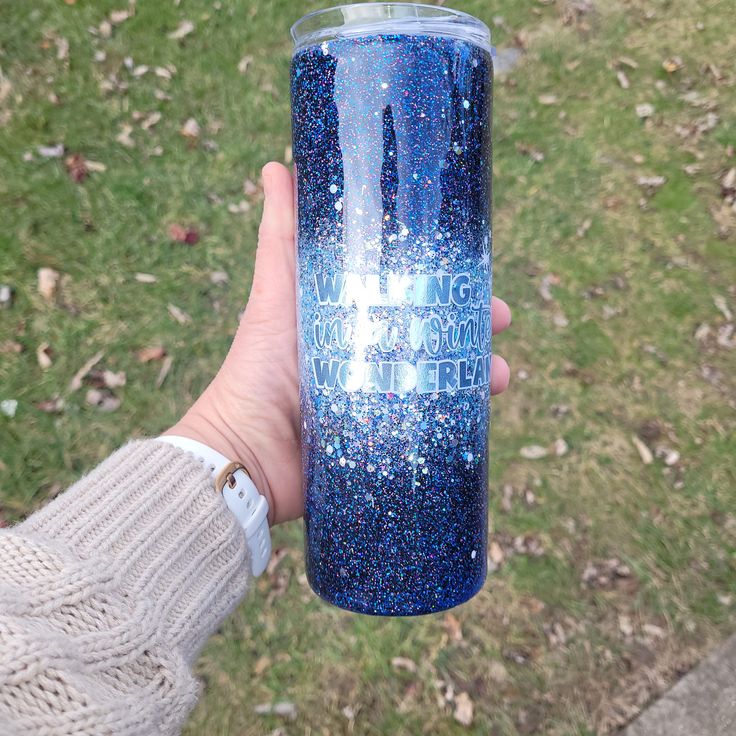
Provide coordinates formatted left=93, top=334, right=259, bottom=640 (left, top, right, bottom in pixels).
left=158, top=434, right=271, bottom=577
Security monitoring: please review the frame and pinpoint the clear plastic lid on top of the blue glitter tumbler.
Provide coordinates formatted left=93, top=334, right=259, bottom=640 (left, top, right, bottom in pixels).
left=291, top=3, right=491, bottom=53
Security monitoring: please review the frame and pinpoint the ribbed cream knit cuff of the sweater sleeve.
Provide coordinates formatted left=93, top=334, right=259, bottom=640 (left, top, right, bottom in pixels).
left=16, top=440, right=250, bottom=662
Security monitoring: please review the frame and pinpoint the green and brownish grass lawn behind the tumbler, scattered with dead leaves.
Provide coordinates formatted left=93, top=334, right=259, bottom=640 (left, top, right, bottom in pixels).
left=0, top=0, right=736, bottom=736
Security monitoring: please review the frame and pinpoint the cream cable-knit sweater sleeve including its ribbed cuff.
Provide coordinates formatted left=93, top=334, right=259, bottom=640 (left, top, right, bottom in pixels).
left=0, top=440, right=250, bottom=736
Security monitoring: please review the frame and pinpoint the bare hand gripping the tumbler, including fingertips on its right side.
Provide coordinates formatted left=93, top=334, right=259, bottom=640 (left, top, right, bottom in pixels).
left=166, top=162, right=511, bottom=524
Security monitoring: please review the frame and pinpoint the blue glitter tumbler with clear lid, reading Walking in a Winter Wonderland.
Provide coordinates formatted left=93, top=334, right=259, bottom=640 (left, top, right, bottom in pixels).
left=291, top=3, right=493, bottom=615
